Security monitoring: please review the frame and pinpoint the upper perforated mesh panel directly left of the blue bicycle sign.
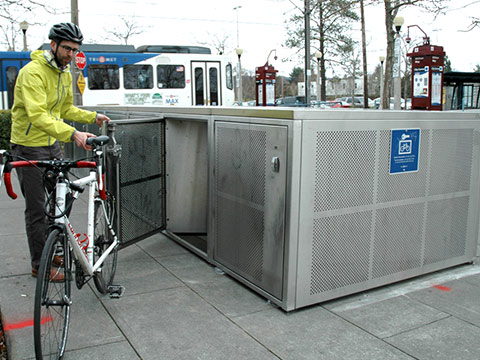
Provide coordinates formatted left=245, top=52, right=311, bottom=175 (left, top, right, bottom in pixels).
left=314, top=131, right=376, bottom=212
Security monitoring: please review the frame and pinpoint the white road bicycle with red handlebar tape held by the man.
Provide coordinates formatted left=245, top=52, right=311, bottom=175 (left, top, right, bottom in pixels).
left=0, top=136, right=125, bottom=360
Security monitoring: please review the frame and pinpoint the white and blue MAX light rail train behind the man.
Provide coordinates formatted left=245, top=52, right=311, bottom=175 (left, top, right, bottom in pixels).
left=0, top=44, right=234, bottom=109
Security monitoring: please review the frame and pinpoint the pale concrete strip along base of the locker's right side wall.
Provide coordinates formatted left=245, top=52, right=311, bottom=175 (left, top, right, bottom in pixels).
left=329, top=265, right=480, bottom=313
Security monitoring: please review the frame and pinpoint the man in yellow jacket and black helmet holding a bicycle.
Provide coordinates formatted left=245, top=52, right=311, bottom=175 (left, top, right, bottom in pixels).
left=10, top=23, right=110, bottom=281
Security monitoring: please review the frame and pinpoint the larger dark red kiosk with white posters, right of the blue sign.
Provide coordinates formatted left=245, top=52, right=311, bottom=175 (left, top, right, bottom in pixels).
left=406, top=25, right=445, bottom=110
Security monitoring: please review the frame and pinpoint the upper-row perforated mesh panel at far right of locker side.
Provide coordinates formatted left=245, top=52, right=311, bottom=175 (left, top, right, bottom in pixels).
left=429, top=129, right=474, bottom=195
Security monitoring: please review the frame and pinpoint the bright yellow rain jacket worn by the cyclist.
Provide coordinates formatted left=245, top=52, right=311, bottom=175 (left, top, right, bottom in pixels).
left=10, top=50, right=97, bottom=147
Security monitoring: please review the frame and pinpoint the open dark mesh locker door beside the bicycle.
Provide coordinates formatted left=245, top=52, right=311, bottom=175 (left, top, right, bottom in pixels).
left=106, top=118, right=166, bottom=247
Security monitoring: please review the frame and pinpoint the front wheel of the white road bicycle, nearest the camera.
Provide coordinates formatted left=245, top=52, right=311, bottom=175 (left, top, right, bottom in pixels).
left=33, top=229, right=71, bottom=360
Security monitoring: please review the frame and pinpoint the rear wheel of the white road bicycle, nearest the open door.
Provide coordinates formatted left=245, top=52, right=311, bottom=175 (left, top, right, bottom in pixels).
left=93, top=192, right=118, bottom=294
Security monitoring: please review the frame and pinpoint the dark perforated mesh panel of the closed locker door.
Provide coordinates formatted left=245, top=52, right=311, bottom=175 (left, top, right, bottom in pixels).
left=215, top=126, right=266, bottom=283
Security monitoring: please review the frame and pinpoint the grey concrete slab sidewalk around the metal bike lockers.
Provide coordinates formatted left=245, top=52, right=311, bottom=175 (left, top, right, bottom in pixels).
left=0, top=173, right=480, bottom=360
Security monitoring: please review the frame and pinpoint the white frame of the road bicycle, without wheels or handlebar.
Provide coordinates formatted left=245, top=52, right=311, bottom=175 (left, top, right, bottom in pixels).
left=55, top=167, right=118, bottom=276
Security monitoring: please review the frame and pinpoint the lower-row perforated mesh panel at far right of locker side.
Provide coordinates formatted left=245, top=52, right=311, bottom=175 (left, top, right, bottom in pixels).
left=424, top=196, right=469, bottom=264
